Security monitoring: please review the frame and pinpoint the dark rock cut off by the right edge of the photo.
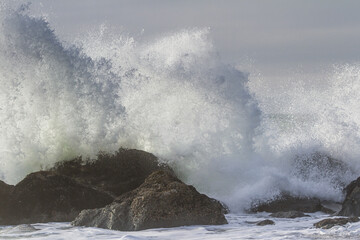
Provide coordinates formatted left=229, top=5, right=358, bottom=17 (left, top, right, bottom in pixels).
left=338, top=177, right=360, bottom=217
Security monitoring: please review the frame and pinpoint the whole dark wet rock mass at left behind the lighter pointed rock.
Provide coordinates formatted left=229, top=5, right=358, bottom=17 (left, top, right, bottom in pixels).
left=0, top=149, right=172, bottom=225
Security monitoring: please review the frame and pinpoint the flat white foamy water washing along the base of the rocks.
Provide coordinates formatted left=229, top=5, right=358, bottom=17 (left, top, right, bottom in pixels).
left=0, top=213, right=360, bottom=240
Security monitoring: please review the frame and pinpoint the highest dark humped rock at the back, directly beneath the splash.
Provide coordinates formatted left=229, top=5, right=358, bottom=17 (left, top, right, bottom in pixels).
left=51, top=149, right=172, bottom=197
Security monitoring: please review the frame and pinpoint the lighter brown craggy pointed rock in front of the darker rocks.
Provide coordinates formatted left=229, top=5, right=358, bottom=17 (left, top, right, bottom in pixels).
left=72, top=171, right=227, bottom=231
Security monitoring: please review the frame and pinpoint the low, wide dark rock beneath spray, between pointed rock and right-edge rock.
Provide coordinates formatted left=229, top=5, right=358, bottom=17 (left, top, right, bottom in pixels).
left=250, top=194, right=334, bottom=213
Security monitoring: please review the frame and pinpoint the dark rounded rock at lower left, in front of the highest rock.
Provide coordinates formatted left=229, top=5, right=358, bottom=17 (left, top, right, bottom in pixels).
left=1, top=171, right=113, bottom=225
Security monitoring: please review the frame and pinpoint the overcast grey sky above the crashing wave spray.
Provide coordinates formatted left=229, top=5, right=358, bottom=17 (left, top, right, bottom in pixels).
left=28, top=0, right=360, bottom=81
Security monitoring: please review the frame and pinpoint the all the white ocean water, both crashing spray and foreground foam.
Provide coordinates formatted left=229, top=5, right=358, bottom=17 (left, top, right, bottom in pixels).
left=0, top=1, right=360, bottom=239
